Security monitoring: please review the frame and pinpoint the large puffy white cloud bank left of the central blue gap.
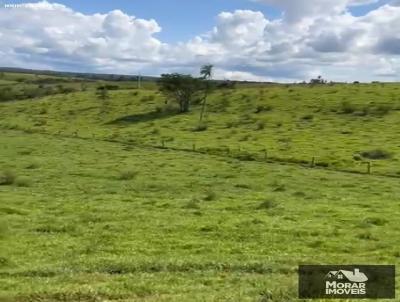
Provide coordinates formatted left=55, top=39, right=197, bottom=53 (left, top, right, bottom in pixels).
left=0, top=2, right=164, bottom=69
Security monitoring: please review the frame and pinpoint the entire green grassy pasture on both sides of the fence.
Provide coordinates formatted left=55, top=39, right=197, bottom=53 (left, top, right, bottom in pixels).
left=0, top=72, right=400, bottom=302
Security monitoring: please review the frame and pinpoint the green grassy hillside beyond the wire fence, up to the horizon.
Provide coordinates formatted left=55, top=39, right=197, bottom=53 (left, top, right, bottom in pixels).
left=0, top=80, right=400, bottom=176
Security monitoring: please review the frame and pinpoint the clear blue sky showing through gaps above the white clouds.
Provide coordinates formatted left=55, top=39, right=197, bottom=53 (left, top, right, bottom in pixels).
left=4, top=0, right=389, bottom=43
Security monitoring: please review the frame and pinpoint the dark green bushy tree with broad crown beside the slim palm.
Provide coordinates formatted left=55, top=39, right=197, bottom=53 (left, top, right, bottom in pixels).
left=158, top=73, right=204, bottom=113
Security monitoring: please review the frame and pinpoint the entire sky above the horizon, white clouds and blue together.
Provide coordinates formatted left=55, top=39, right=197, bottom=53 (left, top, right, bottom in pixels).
left=0, top=0, right=400, bottom=82
